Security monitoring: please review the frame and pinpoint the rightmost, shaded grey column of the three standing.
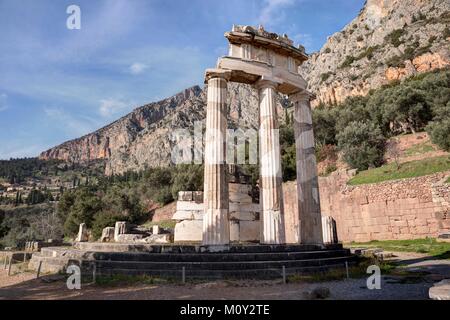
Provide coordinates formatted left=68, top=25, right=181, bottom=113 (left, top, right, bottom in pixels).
left=289, top=91, right=323, bottom=244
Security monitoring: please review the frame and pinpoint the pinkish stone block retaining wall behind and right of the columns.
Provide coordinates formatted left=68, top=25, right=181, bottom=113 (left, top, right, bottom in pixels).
left=283, top=170, right=450, bottom=242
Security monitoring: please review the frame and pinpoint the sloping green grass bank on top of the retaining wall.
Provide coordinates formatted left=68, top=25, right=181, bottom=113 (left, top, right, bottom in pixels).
left=347, top=156, right=450, bottom=185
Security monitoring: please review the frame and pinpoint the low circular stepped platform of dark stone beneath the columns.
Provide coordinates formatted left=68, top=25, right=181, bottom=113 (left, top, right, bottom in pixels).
left=29, top=243, right=356, bottom=278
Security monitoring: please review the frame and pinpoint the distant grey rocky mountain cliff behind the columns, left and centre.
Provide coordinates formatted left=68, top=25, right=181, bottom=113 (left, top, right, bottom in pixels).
left=40, top=83, right=287, bottom=175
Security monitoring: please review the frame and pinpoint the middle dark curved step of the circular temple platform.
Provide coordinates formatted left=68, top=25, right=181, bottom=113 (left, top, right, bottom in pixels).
left=93, top=250, right=350, bottom=263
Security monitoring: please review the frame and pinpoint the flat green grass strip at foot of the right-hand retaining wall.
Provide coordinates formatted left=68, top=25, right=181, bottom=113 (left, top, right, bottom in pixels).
left=346, top=238, right=450, bottom=259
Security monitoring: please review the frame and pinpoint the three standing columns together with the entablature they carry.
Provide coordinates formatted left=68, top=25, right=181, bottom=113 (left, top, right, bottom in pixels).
left=202, top=25, right=323, bottom=245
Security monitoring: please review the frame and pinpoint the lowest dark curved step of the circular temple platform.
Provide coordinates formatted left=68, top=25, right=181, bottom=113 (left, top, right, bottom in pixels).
left=89, top=256, right=352, bottom=272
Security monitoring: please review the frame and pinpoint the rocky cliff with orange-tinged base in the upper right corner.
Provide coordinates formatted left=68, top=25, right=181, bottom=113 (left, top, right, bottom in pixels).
left=301, top=0, right=450, bottom=105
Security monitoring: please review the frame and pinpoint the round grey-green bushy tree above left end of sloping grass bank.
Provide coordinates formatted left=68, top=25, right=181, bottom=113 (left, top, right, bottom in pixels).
left=337, top=121, right=386, bottom=170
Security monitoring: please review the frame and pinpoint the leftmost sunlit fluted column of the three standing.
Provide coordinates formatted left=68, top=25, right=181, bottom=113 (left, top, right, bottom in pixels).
left=203, top=72, right=230, bottom=245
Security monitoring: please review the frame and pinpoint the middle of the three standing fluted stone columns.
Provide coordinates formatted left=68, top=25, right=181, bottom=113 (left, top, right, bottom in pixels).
left=256, top=80, right=286, bottom=244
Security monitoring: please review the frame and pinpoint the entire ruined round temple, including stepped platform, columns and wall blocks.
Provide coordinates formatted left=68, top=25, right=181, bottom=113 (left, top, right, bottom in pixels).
left=29, top=26, right=355, bottom=281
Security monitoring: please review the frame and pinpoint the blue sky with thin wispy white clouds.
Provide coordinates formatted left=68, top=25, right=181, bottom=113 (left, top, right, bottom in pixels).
left=0, top=0, right=364, bottom=159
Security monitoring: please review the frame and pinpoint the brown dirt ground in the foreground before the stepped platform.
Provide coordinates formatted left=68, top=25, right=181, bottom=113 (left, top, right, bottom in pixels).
left=0, top=253, right=450, bottom=300
